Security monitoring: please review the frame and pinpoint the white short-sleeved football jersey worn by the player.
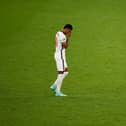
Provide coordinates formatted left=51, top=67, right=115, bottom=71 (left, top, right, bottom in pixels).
left=55, top=31, right=67, bottom=53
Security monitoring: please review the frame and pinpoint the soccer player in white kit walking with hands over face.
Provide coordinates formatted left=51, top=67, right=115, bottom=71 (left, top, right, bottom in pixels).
left=50, top=24, right=73, bottom=96
